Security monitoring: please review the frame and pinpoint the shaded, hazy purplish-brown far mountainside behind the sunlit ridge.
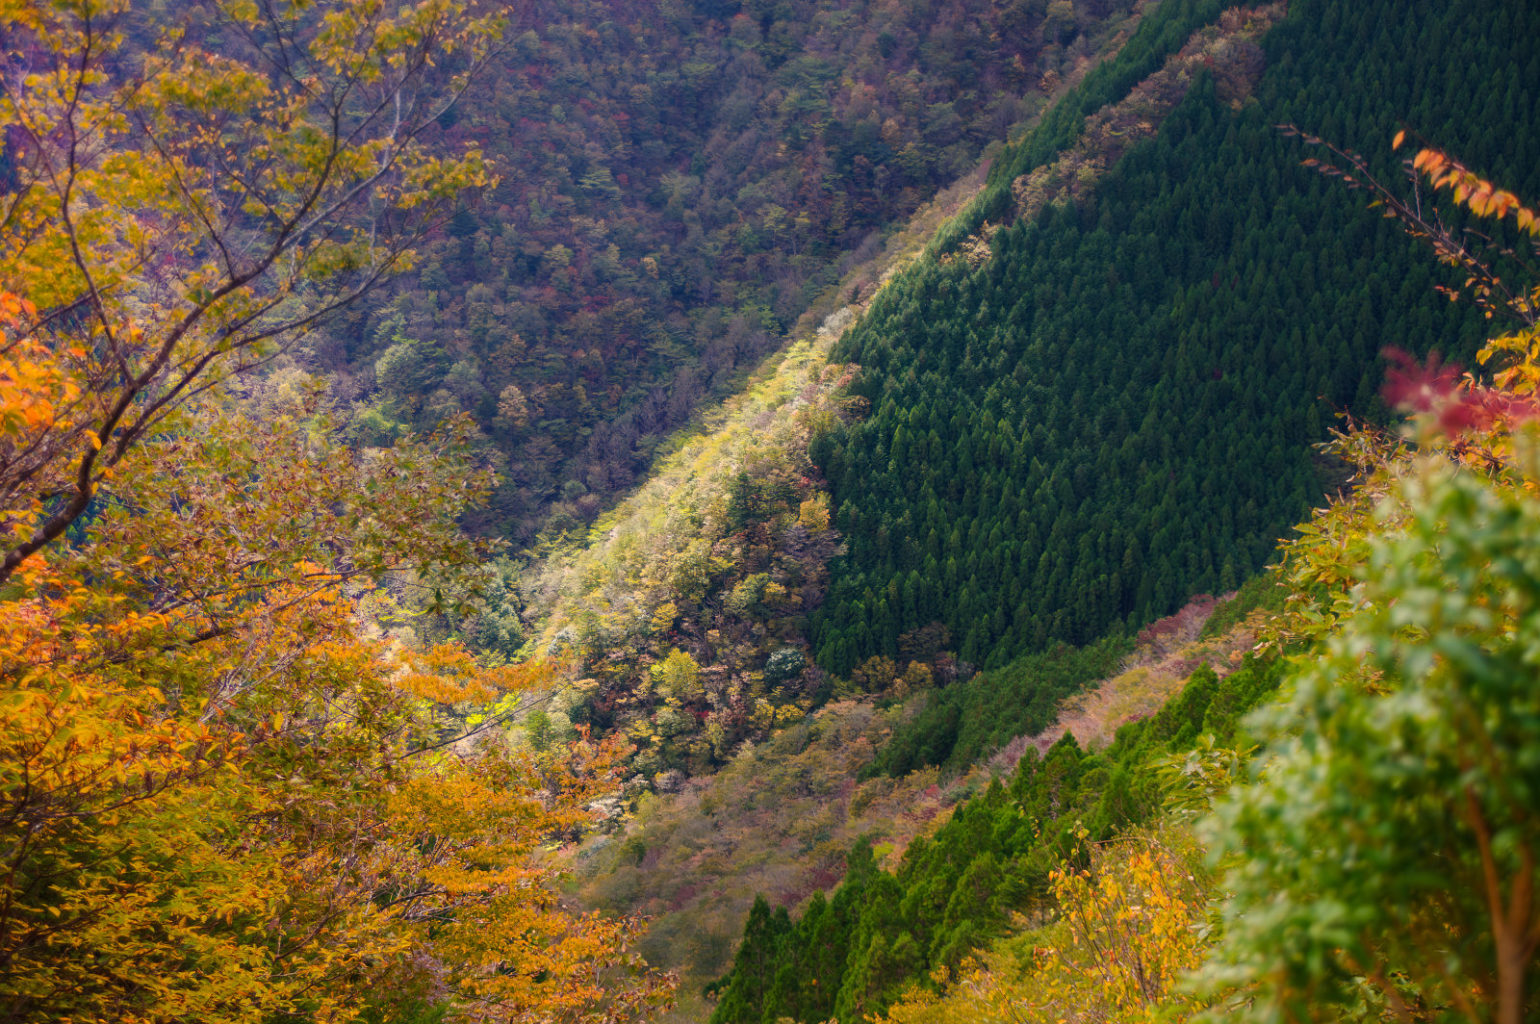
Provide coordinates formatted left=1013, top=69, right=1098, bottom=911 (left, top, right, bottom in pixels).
left=310, top=0, right=1132, bottom=545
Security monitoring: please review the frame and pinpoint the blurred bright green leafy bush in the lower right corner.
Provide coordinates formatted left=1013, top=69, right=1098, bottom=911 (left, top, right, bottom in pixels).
left=1217, top=437, right=1540, bottom=1024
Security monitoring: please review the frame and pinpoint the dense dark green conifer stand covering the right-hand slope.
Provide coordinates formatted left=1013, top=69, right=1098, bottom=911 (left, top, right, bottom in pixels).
left=813, top=0, right=1540, bottom=673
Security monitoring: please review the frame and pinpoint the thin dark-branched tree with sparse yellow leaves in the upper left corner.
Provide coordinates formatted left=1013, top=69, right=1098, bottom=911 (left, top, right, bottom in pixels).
left=0, top=0, right=499, bottom=582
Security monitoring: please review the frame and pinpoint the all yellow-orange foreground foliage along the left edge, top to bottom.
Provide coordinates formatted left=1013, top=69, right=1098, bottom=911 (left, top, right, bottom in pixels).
left=0, top=0, right=668, bottom=1022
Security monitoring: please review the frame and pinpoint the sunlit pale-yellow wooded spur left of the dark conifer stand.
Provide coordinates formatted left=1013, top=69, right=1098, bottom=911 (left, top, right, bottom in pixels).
left=528, top=171, right=1004, bottom=787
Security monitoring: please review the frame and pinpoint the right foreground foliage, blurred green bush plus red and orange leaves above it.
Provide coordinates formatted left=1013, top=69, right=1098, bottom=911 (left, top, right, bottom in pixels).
left=1210, top=151, right=1540, bottom=1024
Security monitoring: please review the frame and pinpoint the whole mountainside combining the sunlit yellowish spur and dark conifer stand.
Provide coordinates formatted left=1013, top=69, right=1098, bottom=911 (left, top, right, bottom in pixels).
left=508, top=0, right=1531, bottom=785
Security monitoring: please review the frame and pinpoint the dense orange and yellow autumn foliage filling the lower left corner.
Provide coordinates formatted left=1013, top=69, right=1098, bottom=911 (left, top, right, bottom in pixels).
left=0, top=300, right=674, bottom=1021
